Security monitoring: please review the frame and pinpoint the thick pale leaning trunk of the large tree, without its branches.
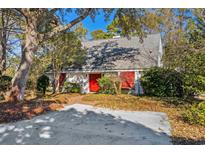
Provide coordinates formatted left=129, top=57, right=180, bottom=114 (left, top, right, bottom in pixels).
left=9, top=20, right=38, bottom=102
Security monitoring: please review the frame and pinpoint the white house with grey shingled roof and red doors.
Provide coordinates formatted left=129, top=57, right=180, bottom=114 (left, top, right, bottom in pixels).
left=54, top=34, right=162, bottom=93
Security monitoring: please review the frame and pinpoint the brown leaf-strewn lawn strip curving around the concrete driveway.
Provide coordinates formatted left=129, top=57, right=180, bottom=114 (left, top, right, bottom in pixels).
left=0, top=94, right=205, bottom=144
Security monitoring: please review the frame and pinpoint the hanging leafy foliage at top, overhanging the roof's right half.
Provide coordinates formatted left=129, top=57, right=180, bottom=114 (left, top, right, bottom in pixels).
left=112, top=8, right=162, bottom=39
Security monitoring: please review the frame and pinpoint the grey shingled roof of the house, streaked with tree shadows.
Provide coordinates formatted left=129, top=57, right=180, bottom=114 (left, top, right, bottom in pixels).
left=63, top=34, right=161, bottom=71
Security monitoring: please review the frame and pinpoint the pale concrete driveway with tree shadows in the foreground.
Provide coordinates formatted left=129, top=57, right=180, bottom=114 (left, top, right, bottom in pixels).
left=0, top=104, right=171, bottom=145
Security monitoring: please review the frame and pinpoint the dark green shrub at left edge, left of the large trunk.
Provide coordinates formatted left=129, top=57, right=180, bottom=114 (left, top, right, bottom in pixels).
left=0, top=75, right=12, bottom=92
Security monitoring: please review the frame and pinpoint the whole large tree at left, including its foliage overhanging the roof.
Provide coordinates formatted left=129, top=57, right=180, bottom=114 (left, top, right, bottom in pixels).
left=6, top=8, right=169, bottom=101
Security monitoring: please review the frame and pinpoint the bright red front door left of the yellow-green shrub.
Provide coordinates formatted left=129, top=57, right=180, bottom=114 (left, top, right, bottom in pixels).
left=89, top=74, right=101, bottom=92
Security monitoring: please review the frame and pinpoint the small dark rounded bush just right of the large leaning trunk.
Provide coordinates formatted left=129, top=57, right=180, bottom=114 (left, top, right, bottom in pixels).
left=36, top=75, right=49, bottom=95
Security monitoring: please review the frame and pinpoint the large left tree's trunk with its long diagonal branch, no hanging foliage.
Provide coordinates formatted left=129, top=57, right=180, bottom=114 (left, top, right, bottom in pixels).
left=10, top=9, right=92, bottom=101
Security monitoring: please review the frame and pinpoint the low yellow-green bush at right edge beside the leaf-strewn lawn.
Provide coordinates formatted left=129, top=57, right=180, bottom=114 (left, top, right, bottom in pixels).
left=182, top=101, right=205, bottom=126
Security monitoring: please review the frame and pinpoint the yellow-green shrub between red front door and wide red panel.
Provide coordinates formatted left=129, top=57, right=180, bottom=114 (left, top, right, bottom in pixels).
left=98, top=76, right=115, bottom=94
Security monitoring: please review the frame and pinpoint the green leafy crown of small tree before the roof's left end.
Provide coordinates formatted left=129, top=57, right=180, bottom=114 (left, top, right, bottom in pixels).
left=38, top=31, right=86, bottom=92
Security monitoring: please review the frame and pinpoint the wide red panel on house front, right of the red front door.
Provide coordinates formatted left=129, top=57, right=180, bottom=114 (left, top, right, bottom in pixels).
left=120, top=72, right=135, bottom=89
